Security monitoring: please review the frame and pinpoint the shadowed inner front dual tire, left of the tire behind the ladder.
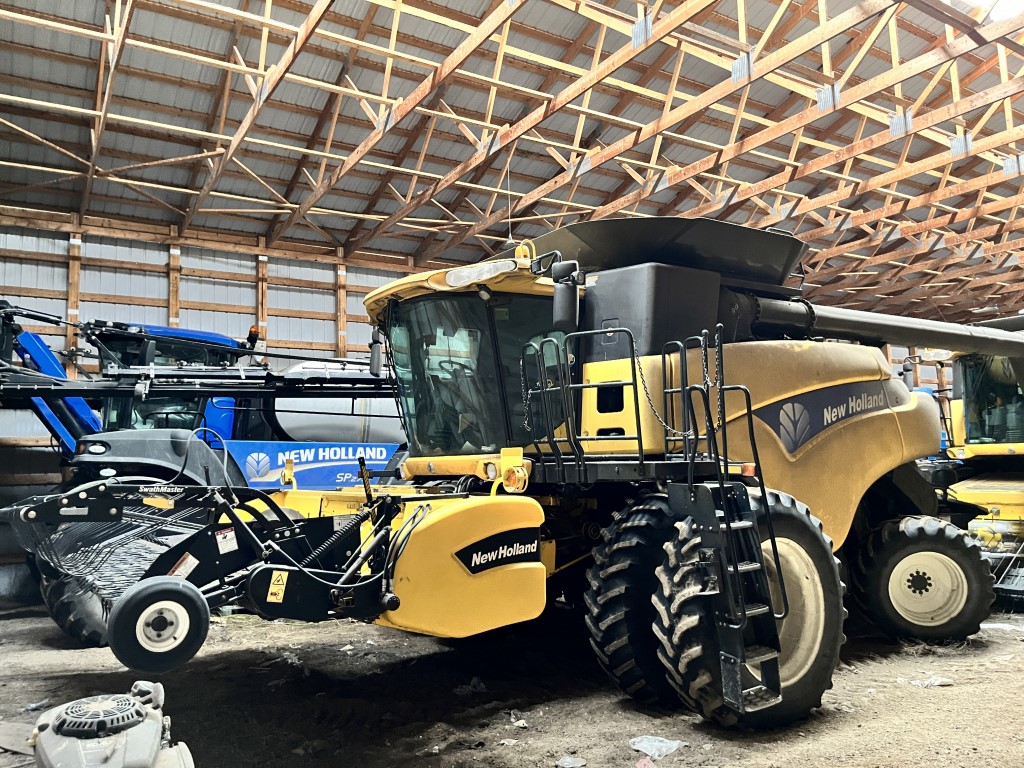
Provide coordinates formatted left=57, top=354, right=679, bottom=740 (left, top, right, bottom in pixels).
left=584, top=495, right=679, bottom=707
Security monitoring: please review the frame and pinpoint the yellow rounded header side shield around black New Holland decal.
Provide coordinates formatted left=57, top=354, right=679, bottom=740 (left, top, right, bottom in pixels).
left=376, top=496, right=547, bottom=637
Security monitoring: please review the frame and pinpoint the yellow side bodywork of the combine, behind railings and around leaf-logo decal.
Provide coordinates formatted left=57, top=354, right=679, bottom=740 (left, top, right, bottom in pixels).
left=581, top=341, right=939, bottom=549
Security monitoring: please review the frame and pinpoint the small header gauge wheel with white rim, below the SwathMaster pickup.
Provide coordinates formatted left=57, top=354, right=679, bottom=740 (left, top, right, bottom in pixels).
left=106, top=577, right=210, bottom=673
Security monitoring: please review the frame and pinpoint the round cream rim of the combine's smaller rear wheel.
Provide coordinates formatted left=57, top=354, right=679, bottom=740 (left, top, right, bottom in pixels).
left=889, top=552, right=968, bottom=627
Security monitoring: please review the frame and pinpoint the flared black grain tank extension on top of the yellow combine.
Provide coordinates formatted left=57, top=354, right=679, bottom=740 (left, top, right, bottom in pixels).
left=491, top=216, right=806, bottom=286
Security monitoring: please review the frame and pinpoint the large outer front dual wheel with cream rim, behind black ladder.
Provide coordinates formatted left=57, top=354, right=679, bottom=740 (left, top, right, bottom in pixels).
left=654, top=488, right=845, bottom=728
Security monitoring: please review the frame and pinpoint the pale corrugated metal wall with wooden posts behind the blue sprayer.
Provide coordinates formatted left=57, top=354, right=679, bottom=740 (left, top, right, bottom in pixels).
left=0, top=227, right=401, bottom=438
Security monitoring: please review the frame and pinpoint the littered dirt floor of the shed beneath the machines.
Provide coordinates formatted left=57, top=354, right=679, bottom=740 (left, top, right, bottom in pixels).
left=0, top=607, right=1024, bottom=768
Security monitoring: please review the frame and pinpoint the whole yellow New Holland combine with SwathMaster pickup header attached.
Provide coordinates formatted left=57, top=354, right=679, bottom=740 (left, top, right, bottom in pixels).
left=9, top=218, right=1024, bottom=726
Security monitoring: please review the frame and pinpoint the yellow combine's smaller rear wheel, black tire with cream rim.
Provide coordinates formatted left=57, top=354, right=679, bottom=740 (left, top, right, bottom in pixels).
left=859, top=516, right=995, bottom=642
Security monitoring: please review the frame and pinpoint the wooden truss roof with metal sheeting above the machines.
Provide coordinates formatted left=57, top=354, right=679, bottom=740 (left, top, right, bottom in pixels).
left=6, top=0, right=1024, bottom=317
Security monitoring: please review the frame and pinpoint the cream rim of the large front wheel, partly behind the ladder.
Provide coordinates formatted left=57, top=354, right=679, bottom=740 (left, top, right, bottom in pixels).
left=762, top=538, right=825, bottom=688
